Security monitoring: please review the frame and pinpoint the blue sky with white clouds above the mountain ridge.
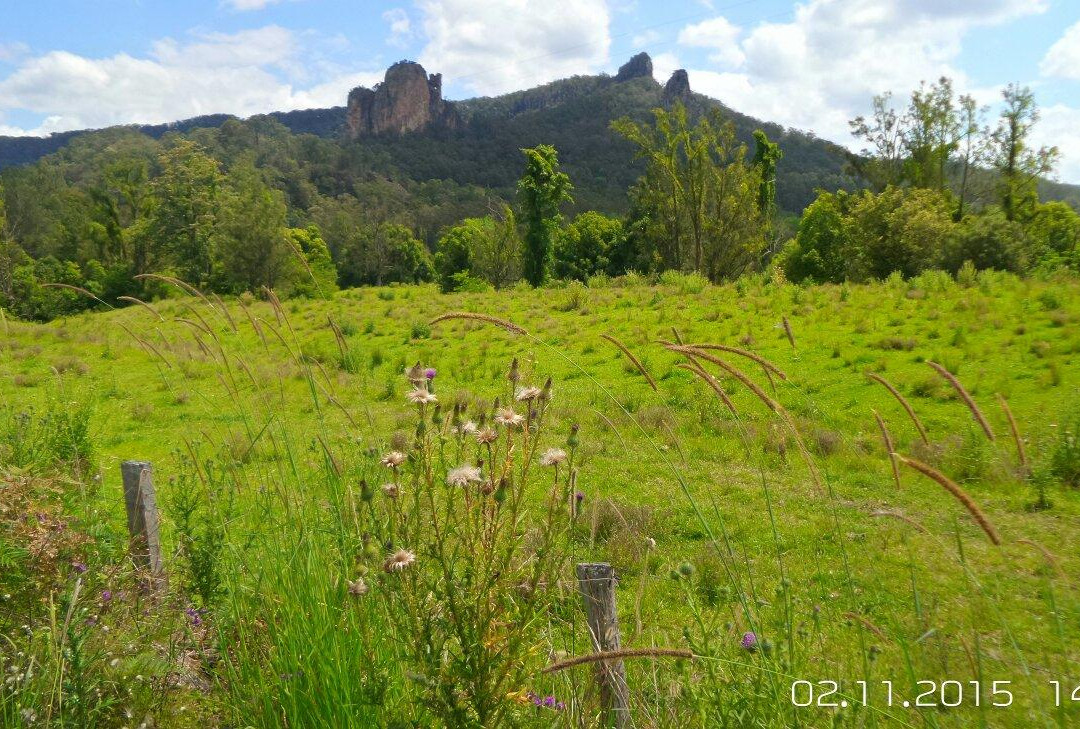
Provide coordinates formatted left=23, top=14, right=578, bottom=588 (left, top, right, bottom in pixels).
left=0, top=0, right=1080, bottom=184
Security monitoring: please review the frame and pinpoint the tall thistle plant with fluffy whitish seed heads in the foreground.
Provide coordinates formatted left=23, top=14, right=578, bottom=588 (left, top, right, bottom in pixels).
left=350, top=363, right=577, bottom=726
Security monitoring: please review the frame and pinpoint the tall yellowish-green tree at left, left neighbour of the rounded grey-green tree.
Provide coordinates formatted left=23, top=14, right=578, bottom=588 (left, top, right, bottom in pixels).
left=147, top=139, right=221, bottom=286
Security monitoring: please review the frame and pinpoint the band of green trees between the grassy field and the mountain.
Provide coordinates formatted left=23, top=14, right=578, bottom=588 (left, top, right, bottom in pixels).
left=0, top=79, right=1080, bottom=320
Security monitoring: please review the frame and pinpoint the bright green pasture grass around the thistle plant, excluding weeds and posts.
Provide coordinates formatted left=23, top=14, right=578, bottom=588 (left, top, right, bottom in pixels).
left=0, top=273, right=1080, bottom=727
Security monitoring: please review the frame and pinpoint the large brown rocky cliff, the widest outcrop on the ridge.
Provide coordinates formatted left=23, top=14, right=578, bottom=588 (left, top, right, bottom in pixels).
left=346, top=60, right=461, bottom=139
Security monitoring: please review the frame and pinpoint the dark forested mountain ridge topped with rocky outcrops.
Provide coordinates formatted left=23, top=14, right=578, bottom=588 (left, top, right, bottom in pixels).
left=0, top=53, right=1080, bottom=213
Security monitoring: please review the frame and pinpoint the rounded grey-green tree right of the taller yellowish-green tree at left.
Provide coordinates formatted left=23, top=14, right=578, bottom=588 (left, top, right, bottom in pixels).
left=215, top=160, right=294, bottom=291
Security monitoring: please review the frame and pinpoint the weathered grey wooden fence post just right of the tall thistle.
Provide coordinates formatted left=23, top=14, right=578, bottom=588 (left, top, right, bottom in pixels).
left=577, top=563, right=630, bottom=729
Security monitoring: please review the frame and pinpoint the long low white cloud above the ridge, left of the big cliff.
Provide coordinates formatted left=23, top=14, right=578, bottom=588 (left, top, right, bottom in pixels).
left=0, top=26, right=382, bottom=134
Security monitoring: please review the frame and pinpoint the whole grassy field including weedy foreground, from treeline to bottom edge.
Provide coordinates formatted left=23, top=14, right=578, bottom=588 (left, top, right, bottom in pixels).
left=0, top=273, right=1080, bottom=727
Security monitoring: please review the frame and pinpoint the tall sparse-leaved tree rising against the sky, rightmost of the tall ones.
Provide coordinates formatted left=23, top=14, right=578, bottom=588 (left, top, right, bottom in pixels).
left=990, top=83, right=1058, bottom=220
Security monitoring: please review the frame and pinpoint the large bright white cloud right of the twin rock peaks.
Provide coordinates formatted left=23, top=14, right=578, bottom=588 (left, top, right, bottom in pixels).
left=680, top=0, right=1045, bottom=144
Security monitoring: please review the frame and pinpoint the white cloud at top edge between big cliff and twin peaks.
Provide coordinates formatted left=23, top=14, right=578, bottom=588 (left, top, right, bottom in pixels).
left=419, top=0, right=611, bottom=94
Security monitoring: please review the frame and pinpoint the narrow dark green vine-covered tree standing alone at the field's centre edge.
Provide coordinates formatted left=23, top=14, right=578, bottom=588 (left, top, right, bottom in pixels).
left=517, top=145, right=573, bottom=286
